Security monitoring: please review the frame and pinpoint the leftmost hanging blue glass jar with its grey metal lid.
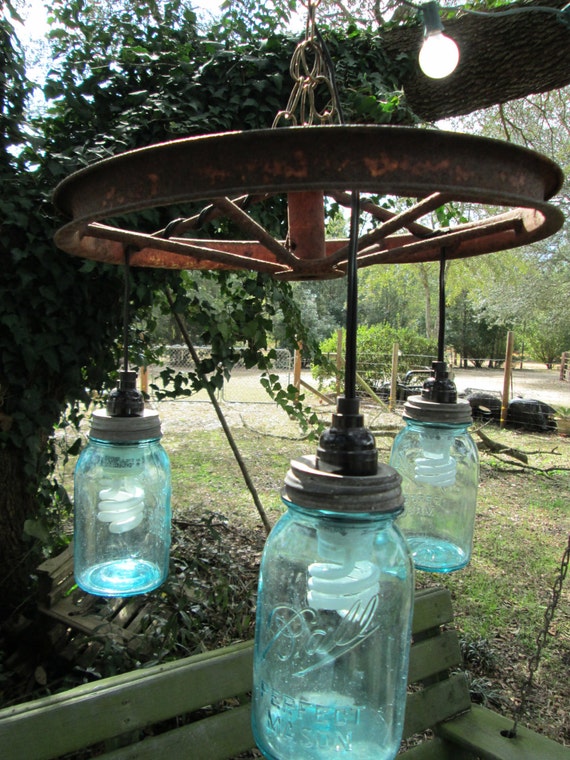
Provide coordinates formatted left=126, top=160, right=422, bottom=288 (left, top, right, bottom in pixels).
left=74, top=410, right=171, bottom=596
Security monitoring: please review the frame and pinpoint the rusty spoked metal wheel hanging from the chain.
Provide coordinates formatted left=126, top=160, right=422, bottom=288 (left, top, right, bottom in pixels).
left=54, top=126, right=564, bottom=280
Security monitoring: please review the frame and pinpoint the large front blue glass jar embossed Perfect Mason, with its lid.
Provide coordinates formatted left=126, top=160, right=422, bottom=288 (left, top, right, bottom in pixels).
left=252, top=457, right=413, bottom=760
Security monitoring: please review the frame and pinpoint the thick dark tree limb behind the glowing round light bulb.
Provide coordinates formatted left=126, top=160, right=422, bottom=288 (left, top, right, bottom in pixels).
left=383, top=0, right=570, bottom=121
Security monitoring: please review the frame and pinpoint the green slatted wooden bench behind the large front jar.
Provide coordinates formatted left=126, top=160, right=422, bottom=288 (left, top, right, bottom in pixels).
left=0, top=589, right=570, bottom=760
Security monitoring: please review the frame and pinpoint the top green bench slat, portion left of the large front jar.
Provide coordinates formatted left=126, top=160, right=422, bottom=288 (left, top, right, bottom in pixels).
left=0, top=642, right=253, bottom=760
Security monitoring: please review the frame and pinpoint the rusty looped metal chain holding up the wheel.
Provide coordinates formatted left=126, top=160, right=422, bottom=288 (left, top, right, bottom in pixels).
left=272, top=0, right=340, bottom=129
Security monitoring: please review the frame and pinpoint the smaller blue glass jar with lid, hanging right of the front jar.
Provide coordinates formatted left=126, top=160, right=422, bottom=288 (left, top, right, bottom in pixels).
left=390, top=396, right=479, bottom=573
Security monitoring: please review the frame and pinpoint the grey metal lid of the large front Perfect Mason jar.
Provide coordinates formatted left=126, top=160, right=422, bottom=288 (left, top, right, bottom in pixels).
left=282, top=456, right=404, bottom=514
